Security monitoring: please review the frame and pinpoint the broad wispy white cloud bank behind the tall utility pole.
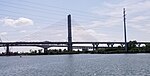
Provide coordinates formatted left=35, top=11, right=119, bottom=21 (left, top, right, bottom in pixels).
left=84, top=0, right=150, bottom=41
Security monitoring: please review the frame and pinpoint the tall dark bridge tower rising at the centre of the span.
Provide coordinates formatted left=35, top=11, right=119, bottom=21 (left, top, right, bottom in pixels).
left=68, top=14, right=72, bottom=51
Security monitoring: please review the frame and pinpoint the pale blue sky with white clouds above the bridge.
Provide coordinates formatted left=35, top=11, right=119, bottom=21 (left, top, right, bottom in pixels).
left=0, top=0, right=150, bottom=50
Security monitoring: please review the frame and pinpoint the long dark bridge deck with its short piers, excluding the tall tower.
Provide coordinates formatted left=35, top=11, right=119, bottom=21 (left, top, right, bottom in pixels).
left=0, top=42, right=150, bottom=55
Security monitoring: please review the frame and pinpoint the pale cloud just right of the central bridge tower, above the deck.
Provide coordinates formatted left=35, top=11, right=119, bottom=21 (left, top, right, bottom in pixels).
left=72, top=25, right=107, bottom=42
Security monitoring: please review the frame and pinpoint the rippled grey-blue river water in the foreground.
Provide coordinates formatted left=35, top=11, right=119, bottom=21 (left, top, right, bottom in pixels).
left=0, top=54, right=150, bottom=76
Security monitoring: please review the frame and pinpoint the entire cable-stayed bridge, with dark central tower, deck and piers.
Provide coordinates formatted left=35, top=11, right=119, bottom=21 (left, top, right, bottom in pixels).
left=0, top=15, right=150, bottom=55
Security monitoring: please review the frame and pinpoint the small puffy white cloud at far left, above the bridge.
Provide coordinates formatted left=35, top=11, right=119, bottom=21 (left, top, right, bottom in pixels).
left=1, top=17, right=34, bottom=26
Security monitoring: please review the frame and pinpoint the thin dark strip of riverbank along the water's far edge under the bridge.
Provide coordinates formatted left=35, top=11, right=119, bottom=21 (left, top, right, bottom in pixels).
left=0, top=50, right=150, bottom=56
